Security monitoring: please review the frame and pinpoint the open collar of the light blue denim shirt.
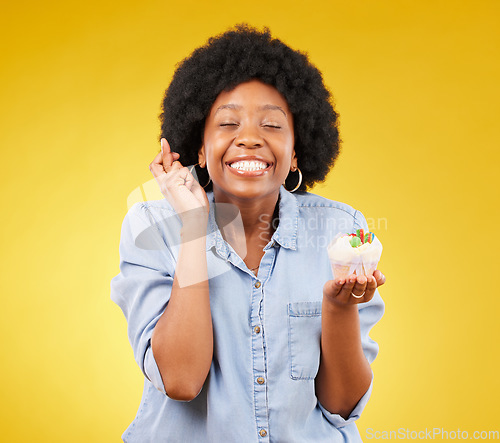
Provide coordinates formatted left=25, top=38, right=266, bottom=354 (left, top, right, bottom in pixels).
left=207, top=185, right=299, bottom=255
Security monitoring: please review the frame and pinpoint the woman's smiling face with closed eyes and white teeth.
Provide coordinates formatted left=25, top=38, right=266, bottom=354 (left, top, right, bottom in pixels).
left=198, top=80, right=297, bottom=202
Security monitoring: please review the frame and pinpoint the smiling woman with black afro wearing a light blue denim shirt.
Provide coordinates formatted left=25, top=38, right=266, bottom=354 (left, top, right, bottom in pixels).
left=111, top=26, right=385, bottom=442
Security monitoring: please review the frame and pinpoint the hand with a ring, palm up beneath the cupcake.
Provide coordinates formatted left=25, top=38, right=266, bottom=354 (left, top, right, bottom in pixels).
left=323, top=269, right=385, bottom=306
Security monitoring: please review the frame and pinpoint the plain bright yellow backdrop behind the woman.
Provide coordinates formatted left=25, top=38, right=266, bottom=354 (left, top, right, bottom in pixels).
left=0, top=0, right=500, bottom=442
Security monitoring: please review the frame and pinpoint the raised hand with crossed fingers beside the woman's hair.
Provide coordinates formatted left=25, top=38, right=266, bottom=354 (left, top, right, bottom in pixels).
left=149, top=138, right=210, bottom=224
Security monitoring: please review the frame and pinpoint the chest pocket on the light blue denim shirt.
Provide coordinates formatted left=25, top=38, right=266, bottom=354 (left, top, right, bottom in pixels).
left=288, top=301, right=321, bottom=380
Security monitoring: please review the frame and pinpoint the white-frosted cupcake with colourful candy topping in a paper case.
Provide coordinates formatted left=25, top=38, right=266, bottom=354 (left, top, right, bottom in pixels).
left=328, top=229, right=382, bottom=278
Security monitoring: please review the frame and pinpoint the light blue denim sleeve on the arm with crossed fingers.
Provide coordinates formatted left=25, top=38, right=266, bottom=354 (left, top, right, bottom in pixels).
left=111, top=203, right=179, bottom=393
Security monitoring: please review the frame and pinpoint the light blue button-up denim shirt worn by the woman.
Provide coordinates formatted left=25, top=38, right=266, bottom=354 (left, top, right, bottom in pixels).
left=111, top=186, right=384, bottom=443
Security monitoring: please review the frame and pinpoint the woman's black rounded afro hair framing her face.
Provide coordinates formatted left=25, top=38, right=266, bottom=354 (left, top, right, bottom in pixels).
left=159, top=24, right=340, bottom=191
